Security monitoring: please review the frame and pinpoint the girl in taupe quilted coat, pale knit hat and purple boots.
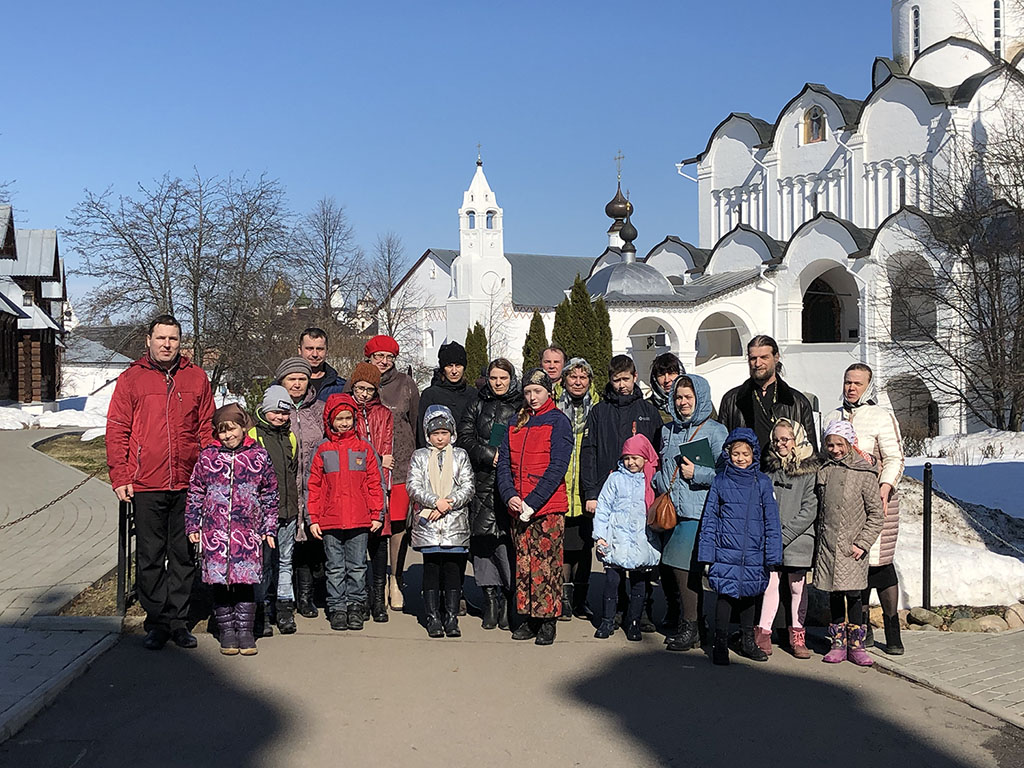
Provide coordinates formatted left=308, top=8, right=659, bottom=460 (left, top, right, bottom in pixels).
left=814, top=421, right=883, bottom=667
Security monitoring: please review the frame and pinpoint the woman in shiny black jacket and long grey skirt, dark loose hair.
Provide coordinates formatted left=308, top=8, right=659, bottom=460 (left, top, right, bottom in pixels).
left=457, top=357, right=522, bottom=630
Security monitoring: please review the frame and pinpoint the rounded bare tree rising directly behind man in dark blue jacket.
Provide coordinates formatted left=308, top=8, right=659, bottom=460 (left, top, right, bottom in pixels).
left=294, top=197, right=360, bottom=321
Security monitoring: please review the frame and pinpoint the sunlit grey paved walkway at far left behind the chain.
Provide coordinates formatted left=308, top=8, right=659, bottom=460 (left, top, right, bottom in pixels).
left=0, top=429, right=118, bottom=627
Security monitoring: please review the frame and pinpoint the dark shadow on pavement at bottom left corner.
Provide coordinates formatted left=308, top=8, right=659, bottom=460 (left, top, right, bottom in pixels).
left=0, top=635, right=287, bottom=768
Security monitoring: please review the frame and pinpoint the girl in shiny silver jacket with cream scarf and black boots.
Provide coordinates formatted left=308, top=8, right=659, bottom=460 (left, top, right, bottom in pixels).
left=406, top=406, right=475, bottom=637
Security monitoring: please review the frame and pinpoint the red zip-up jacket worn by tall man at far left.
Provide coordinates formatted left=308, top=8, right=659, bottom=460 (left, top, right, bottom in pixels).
left=106, top=354, right=213, bottom=490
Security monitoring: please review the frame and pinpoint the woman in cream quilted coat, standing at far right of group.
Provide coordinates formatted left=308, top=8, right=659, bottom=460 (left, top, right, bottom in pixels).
left=823, top=362, right=904, bottom=655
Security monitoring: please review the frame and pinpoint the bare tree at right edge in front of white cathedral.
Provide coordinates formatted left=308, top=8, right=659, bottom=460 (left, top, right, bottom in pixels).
left=886, top=103, right=1024, bottom=431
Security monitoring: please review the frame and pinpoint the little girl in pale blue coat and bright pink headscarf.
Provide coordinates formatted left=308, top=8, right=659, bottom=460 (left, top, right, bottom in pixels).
left=594, top=434, right=662, bottom=640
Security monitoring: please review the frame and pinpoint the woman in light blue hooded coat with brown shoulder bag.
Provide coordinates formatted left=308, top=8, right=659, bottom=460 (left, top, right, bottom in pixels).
left=654, top=374, right=728, bottom=650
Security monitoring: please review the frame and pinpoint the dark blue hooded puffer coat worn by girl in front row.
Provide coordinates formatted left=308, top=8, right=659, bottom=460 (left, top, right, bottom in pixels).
left=697, top=427, right=782, bottom=597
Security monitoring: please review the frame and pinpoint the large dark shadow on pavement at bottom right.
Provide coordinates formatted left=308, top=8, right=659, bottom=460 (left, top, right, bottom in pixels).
left=566, top=651, right=1020, bottom=768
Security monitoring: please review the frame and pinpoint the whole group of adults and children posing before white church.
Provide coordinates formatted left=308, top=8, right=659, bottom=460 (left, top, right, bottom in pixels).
left=106, top=315, right=903, bottom=665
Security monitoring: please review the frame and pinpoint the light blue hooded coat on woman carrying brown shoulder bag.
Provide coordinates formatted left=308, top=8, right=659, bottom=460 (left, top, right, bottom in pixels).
left=654, top=374, right=728, bottom=520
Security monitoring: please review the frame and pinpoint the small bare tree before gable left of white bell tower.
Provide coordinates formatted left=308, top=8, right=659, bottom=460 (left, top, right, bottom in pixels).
left=365, top=232, right=424, bottom=354
